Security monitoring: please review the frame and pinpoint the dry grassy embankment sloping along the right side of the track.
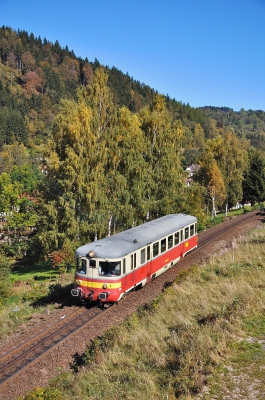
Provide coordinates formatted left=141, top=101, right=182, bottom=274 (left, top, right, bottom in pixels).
left=19, top=208, right=265, bottom=400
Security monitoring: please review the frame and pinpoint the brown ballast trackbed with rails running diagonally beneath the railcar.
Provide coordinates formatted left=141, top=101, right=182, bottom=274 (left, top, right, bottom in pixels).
left=0, top=211, right=260, bottom=400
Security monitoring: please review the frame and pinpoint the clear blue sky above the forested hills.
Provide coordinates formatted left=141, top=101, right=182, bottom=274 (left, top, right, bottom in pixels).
left=0, top=0, right=265, bottom=111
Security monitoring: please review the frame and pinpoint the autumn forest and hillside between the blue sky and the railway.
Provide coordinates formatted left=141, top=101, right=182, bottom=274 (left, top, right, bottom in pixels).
left=0, top=27, right=265, bottom=266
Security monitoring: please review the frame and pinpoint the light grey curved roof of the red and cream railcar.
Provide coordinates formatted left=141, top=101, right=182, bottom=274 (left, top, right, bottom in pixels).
left=76, top=214, right=197, bottom=259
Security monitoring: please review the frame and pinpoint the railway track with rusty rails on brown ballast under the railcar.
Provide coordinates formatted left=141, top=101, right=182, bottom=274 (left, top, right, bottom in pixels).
left=0, top=212, right=264, bottom=400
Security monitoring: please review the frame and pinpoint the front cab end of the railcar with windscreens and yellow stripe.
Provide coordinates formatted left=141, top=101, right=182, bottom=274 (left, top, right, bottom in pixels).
left=71, top=250, right=121, bottom=303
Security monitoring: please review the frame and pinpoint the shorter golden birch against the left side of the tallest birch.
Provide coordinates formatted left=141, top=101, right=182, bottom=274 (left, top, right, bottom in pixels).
left=38, top=100, right=93, bottom=254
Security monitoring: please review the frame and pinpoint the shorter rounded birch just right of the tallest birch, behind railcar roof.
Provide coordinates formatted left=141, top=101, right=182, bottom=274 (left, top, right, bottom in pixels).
left=107, top=107, right=149, bottom=228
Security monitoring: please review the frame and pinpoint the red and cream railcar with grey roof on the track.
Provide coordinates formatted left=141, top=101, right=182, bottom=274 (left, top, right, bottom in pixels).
left=71, top=214, right=198, bottom=305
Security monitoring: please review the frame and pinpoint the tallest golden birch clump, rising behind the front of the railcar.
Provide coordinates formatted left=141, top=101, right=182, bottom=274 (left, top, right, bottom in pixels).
left=39, top=65, right=115, bottom=252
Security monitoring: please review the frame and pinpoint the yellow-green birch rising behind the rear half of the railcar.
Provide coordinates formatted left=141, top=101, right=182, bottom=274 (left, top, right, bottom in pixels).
left=139, top=95, right=184, bottom=218
